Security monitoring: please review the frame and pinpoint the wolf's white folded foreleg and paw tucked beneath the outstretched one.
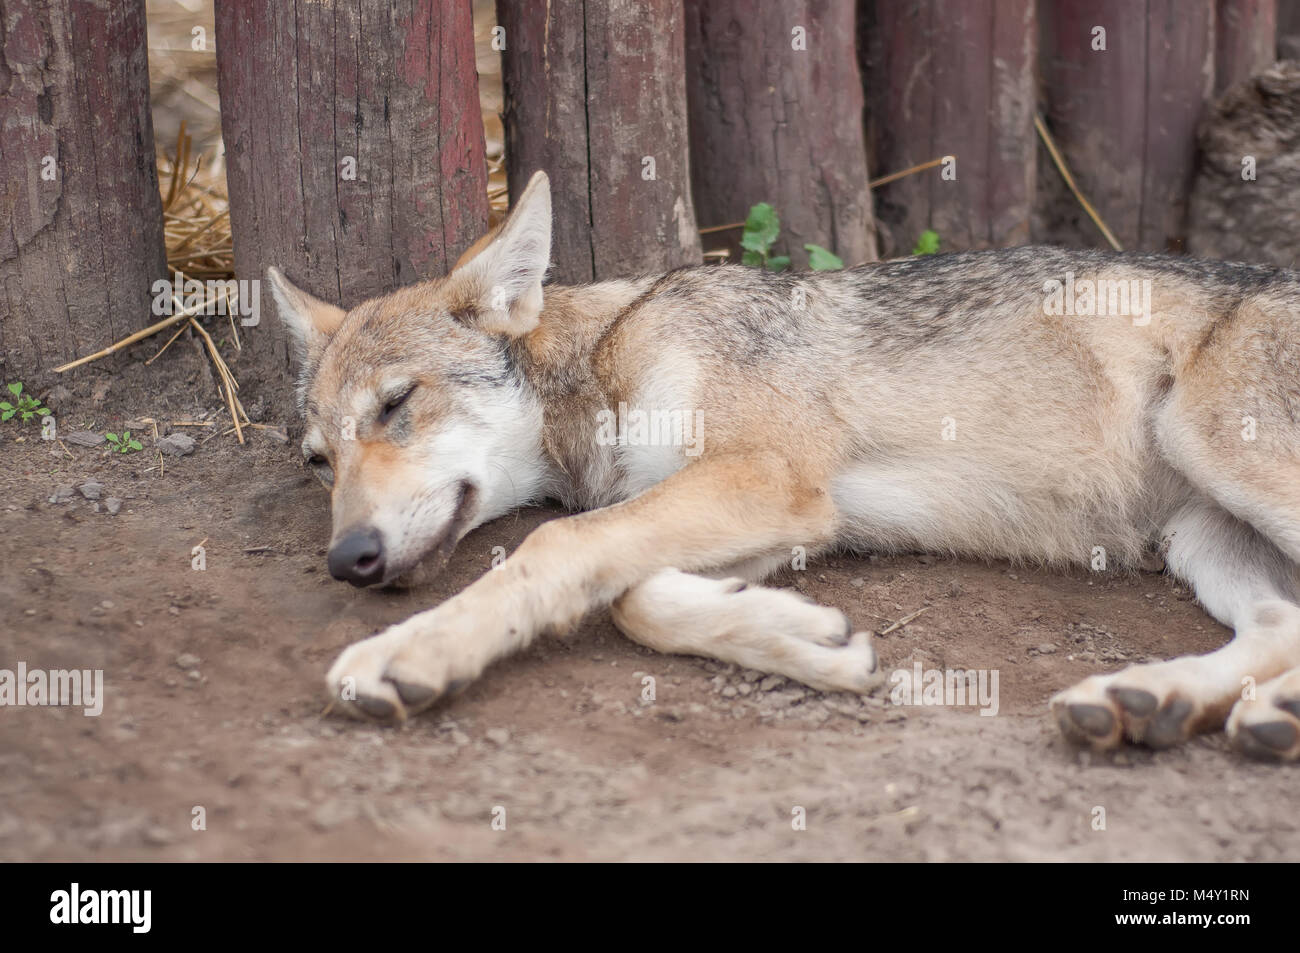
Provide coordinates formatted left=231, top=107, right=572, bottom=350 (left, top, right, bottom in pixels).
left=611, top=569, right=884, bottom=693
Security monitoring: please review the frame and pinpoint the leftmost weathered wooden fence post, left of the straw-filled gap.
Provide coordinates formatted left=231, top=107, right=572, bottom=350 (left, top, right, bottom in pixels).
left=0, top=0, right=166, bottom=389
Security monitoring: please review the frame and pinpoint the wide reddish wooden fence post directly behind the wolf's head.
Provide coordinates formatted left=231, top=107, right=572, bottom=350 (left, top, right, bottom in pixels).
left=216, top=0, right=488, bottom=377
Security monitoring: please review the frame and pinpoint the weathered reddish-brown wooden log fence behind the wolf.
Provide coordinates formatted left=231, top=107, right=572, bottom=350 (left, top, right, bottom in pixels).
left=0, top=0, right=1300, bottom=380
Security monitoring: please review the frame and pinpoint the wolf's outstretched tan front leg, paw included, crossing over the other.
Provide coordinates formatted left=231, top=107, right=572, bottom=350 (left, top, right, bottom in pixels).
left=326, top=452, right=835, bottom=720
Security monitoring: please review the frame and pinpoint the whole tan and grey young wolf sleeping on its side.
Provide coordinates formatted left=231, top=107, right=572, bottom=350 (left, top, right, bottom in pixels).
left=268, top=173, right=1300, bottom=761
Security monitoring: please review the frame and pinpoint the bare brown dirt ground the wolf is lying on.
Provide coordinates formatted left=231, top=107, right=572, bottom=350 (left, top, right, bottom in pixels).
left=0, top=342, right=1300, bottom=861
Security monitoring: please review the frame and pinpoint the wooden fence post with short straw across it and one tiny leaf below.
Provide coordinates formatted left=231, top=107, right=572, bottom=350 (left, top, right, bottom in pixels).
left=859, top=0, right=1037, bottom=257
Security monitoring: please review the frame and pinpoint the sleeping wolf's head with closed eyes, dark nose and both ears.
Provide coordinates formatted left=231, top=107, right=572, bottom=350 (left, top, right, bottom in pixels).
left=267, top=173, right=551, bottom=586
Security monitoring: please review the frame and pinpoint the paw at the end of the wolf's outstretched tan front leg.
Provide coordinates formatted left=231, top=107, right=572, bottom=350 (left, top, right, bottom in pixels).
left=325, top=620, right=477, bottom=722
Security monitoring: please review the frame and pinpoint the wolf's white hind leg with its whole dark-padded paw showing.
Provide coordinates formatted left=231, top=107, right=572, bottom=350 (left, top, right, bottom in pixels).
left=1052, top=498, right=1300, bottom=749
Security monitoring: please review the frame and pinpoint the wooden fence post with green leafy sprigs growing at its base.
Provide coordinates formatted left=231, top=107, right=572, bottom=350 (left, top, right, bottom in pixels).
left=686, top=0, right=876, bottom=268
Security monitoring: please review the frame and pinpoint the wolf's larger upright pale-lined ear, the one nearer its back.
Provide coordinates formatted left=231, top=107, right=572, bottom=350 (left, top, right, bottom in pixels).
left=447, top=172, right=551, bottom=338
